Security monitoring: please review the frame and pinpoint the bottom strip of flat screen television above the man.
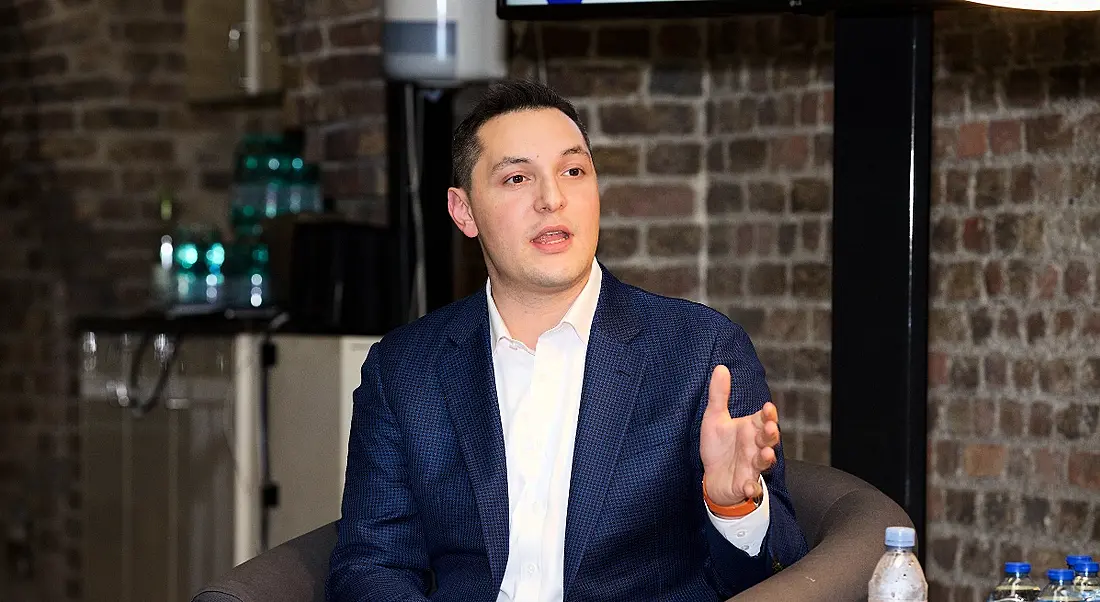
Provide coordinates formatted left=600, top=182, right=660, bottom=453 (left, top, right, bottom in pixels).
left=496, top=0, right=968, bottom=21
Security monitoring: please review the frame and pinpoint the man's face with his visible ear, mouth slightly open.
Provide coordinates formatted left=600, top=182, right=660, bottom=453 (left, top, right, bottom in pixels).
left=448, top=109, right=600, bottom=293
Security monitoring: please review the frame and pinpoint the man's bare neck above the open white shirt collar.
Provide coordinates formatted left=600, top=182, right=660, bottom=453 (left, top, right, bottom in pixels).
left=492, top=271, right=592, bottom=350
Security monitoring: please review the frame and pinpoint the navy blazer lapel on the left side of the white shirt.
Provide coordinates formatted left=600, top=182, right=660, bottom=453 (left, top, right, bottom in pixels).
left=439, top=291, right=508, bottom=589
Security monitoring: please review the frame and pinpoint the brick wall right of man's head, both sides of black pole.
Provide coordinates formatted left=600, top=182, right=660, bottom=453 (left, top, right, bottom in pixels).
left=514, top=10, right=1100, bottom=602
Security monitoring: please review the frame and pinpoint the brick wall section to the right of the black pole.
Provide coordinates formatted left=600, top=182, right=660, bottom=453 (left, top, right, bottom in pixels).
left=928, top=10, right=1100, bottom=602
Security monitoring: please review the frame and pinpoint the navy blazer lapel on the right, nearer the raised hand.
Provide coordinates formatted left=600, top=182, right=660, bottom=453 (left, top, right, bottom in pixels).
left=563, top=269, right=646, bottom=600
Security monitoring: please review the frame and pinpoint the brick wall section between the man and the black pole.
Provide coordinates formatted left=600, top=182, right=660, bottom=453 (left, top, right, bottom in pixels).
left=513, top=17, right=833, bottom=462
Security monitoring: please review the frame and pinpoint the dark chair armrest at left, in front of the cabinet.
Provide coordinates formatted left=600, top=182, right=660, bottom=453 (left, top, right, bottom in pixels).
left=193, top=523, right=337, bottom=602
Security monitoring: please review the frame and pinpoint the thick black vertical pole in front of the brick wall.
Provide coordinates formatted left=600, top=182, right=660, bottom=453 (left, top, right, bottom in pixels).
left=831, top=12, right=932, bottom=562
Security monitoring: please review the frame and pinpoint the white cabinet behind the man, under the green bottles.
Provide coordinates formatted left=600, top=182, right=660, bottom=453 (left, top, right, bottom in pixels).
left=80, top=332, right=381, bottom=602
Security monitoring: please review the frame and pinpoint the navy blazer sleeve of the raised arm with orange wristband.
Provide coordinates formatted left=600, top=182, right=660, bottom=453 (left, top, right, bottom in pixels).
left=695, top=320, right=807, bottom=595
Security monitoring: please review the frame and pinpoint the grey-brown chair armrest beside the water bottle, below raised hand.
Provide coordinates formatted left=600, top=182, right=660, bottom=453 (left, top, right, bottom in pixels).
left=728, top=488, right=913, bottom=602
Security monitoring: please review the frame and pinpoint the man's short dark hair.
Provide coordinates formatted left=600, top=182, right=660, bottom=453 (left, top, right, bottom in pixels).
left=451, top=79, right=592, bottom=193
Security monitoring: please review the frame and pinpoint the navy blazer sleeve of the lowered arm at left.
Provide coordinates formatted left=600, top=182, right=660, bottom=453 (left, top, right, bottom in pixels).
left=325, top=343, right=430, bottom=602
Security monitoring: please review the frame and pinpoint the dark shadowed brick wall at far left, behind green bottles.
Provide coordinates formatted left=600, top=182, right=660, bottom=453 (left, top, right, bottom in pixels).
left=0, top=0, right=278, bottom=601
